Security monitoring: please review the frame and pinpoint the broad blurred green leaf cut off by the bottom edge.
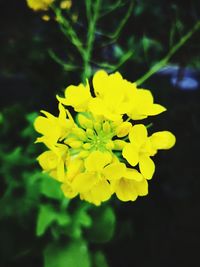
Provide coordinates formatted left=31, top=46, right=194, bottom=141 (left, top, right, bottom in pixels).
left=44, top=240, right=91, bottom=267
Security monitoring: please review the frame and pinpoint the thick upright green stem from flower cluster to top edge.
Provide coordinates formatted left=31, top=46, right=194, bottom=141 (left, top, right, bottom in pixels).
left=82, top=0, right=101, bottom=82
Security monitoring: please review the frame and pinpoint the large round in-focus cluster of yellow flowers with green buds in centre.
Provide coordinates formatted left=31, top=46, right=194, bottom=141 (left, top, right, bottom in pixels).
left=34, top=70, right=175, bottom=205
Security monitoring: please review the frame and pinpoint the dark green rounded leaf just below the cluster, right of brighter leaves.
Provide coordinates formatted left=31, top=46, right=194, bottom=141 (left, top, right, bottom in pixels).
left=87, top=206, right=116, bottom=243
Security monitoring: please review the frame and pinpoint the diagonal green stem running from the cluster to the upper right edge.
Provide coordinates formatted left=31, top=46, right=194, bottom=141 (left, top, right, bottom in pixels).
left=136, top=21, right=200, bottom=85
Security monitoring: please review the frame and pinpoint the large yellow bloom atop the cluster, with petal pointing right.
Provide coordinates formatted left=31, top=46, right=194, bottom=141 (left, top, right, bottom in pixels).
left=89, top=71, right=166, bottom=120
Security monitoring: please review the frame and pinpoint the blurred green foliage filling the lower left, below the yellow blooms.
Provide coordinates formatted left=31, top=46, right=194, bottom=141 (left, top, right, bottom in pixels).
left=0, top=108, right=112, bottom=267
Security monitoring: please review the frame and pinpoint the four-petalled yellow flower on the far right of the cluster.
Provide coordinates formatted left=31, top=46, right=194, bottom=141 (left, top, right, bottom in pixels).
left=122, top=124, right=175, bottom=179
